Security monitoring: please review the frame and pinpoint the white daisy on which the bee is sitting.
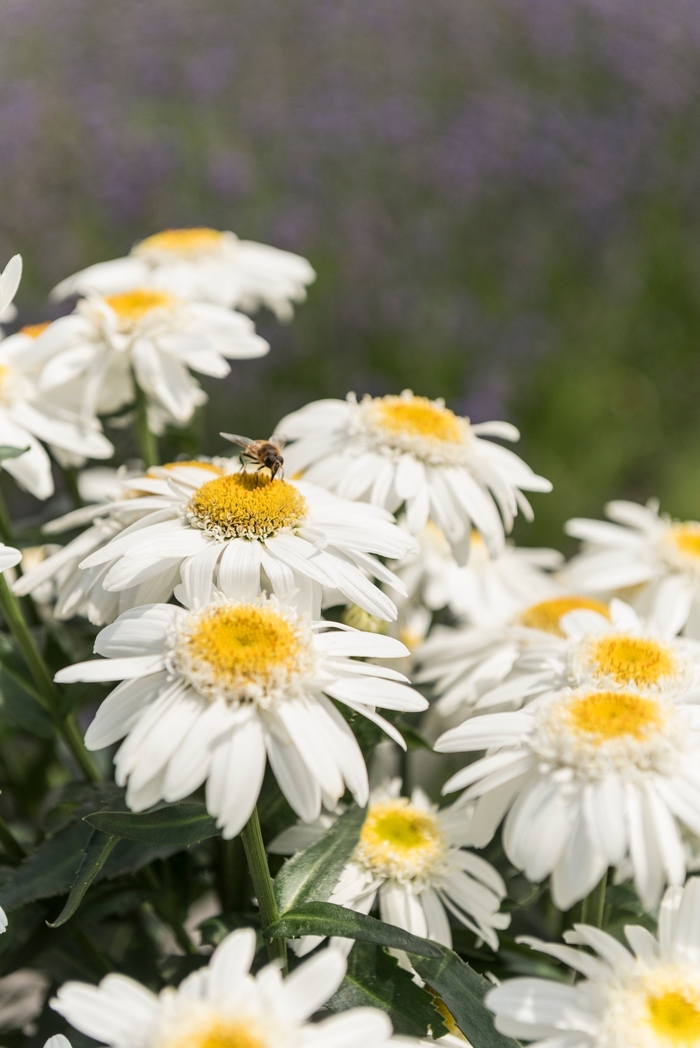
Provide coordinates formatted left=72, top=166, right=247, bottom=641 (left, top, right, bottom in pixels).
left=73, top=459, right=413, bottom=619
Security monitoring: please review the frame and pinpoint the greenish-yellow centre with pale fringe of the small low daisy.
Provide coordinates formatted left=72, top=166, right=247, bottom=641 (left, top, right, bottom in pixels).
left=355, top=798, right=446, bottom=881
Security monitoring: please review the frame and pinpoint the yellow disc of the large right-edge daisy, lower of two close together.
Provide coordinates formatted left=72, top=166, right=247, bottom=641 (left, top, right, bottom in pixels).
left=567, top=692, right=661, bottom=743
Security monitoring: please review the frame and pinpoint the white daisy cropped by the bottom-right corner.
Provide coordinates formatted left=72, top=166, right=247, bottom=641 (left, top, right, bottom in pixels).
left=485, top=877, right=700, bottom=1048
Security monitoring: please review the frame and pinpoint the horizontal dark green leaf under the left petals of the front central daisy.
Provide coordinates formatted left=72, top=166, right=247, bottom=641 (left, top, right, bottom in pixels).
left=85, top=802, right=219, bottom=848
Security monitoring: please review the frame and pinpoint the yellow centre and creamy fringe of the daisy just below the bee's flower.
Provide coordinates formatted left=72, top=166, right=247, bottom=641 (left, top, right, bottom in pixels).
left=174, top=604, right=306, bottom=702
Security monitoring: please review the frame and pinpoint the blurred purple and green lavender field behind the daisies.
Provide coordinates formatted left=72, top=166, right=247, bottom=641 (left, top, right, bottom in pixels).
left=0, top=0, right=700, bottom=544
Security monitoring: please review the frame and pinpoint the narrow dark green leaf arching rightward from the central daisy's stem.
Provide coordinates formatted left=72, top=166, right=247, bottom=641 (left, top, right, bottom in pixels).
left=265, top=902, right=442, bottom=959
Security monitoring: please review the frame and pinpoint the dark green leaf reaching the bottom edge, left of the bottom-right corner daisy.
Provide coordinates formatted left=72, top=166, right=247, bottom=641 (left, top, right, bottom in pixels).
left=409, top=946, right=518, bottom=1048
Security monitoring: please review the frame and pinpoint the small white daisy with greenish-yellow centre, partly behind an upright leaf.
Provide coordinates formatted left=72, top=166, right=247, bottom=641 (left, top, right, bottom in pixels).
left=269, top=779, right=510, bottom=956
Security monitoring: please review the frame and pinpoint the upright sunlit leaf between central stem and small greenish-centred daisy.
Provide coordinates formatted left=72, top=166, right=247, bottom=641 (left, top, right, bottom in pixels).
left=275, top=806, right=366, bottom=914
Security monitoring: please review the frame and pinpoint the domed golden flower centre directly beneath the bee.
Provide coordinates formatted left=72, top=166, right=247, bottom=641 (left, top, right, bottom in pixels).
left=188, top=473, right=307, bottom=539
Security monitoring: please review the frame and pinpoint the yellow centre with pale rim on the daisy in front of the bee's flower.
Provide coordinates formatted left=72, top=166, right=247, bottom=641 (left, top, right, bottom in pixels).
left=176, top=604, right=301, bottom=691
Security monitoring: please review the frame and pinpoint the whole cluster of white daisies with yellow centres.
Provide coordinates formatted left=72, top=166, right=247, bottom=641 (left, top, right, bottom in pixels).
left=0, top=228, right=700, bottom=1048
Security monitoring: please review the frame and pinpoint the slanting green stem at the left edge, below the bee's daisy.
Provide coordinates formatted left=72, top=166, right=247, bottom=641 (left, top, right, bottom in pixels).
left=0, top=572, right=100, bottom=782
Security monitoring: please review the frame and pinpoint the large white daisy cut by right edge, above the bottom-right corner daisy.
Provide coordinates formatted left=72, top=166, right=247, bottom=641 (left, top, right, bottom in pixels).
left=435, top=670, right=700, bottom=910
